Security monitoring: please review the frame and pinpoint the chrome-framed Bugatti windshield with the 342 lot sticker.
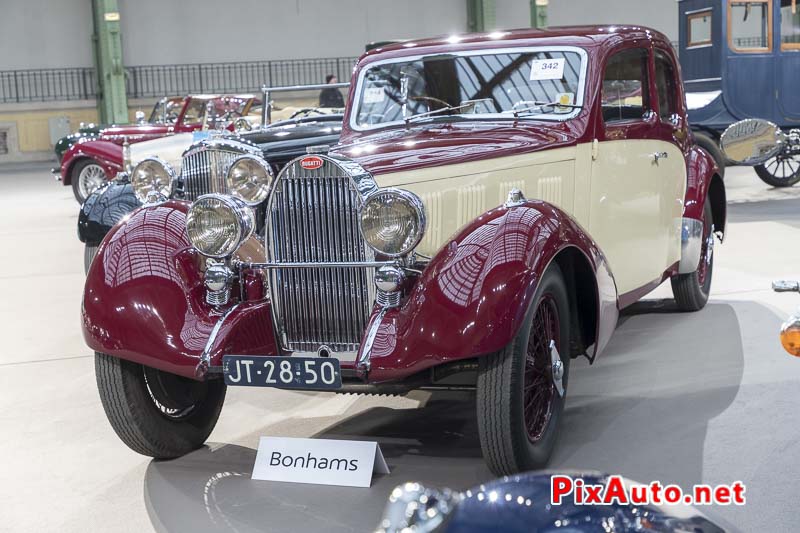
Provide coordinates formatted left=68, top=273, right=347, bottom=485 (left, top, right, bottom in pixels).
left=351, top=48, right=586, bottom=129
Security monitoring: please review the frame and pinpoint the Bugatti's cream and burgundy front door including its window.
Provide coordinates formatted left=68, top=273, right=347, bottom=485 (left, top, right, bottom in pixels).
left=589, top=45, right=683, bottom=300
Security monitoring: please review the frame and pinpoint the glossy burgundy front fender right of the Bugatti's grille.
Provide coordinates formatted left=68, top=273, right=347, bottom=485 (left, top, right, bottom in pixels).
left=359, top=201, right=617, bottom=382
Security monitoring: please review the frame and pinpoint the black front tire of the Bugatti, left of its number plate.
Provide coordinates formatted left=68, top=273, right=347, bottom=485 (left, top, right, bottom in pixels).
left=95, top=353, right=226, bottom=459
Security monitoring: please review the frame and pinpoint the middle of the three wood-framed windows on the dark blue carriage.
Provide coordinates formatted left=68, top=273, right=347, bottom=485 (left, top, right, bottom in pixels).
left=728, top=0, right=772, bottom=52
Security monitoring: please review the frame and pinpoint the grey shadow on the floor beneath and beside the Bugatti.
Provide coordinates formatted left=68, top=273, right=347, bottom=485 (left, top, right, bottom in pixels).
left=144, top=300, right=744, bottom=532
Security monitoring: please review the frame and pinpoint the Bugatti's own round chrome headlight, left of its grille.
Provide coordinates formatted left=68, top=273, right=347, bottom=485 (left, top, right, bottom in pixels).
left=186, top=194, right=256, bottom=259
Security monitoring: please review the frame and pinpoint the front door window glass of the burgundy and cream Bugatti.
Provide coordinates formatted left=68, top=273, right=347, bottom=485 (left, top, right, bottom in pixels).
left=601, top=48, right=651, bottom=124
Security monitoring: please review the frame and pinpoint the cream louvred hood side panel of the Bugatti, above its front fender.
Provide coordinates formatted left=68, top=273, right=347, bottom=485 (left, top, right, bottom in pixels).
left=374, top=147, right=584, bottom=256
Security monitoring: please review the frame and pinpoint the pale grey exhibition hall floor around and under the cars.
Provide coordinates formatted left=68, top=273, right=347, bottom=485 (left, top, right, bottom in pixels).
left=0, top=166, right=800, bottom=532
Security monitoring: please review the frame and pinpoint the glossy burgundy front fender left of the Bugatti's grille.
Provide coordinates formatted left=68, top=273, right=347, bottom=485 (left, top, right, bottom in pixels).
left=82, top=201, right=278, bottom=379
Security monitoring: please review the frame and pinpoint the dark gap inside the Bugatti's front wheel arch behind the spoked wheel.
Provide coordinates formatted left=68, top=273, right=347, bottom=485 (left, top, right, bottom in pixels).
left=553, top=246, right=599, bottom=357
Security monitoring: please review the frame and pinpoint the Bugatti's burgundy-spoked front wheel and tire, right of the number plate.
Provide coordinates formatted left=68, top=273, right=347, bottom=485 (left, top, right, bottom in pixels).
left=477, top=264, right=570, bottom=476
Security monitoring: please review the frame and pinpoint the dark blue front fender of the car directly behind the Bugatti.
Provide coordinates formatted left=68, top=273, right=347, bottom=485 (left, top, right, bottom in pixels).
left=78, top=181, right=142, bottom=246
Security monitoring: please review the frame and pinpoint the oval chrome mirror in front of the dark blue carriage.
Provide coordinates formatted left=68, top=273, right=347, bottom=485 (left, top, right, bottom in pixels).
left=719, top=118, right=785, bottom=166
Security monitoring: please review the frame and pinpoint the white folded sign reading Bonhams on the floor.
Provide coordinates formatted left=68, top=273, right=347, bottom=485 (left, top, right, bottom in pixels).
left=251, top=437, right=389, bottom=487
